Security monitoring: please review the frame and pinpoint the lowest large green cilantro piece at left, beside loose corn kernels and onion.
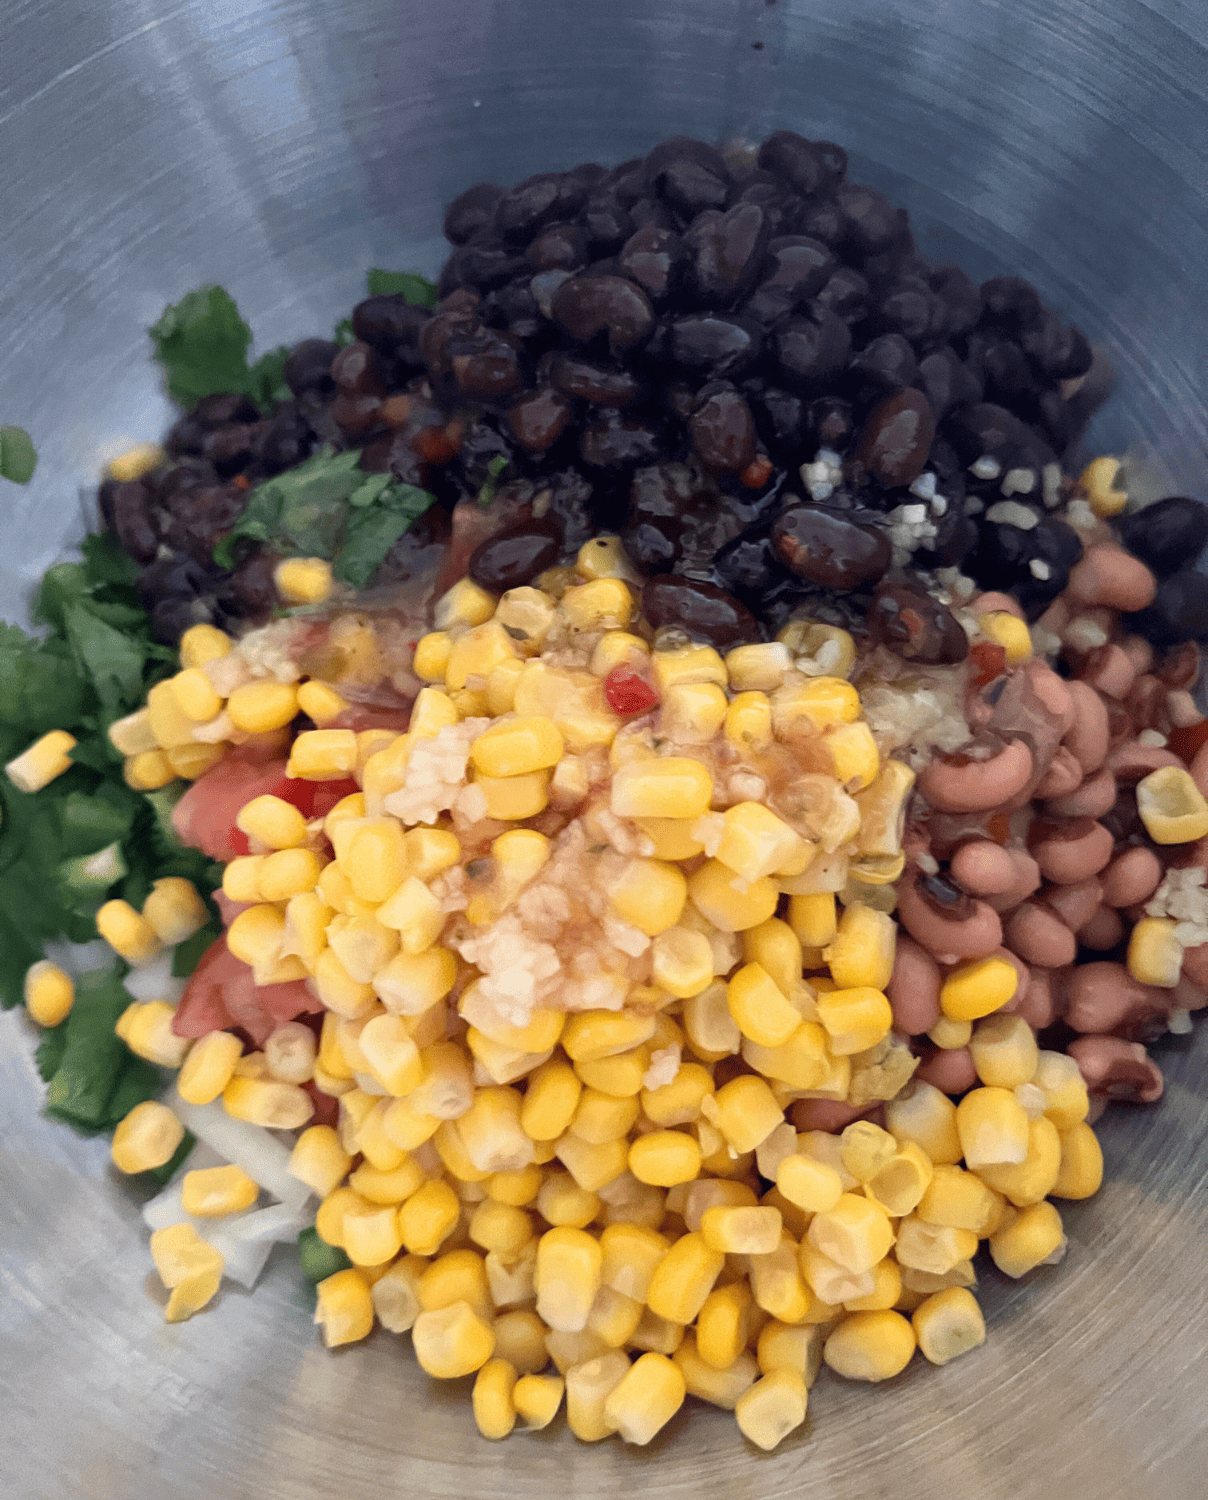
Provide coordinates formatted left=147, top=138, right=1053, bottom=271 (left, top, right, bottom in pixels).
left=47, top=969, right=138, bottom=1131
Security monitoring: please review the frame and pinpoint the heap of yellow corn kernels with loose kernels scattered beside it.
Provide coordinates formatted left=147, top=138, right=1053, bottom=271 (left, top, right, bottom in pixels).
left=47, top=542, right=1110, bottom=1449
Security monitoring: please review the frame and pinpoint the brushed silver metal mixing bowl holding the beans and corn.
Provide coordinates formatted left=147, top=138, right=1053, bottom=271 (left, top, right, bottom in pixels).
left=0, top=0, right=1208, bottom=1500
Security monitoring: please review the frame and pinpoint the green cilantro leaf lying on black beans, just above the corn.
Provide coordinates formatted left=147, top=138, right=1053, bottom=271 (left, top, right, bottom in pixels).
left=215, top=447, right=366, bottom=567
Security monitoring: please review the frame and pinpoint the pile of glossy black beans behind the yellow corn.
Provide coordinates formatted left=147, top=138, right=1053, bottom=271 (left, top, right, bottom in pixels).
left=102, top=131, right=1208, bottom=659
